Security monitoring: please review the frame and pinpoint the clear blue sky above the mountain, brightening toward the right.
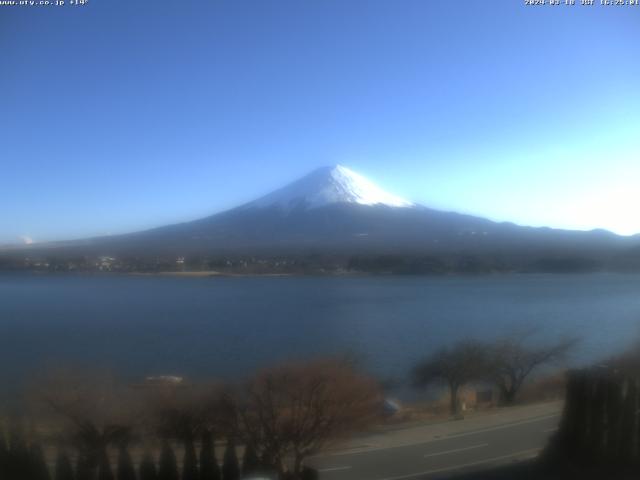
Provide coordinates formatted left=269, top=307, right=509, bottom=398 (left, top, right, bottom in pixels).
left=0, top=0, right=640, bottom=243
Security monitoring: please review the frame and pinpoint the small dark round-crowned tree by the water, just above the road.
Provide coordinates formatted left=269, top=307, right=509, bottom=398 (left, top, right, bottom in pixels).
left=413, top=340, right=488, bottom=415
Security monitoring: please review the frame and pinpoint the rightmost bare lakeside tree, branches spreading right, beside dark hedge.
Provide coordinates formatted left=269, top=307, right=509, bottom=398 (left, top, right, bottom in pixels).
left=489, top=330, right=576, bottom=404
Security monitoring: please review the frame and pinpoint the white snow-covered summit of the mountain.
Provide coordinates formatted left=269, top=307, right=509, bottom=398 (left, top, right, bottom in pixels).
left=246, top=165, right=415, bottom=211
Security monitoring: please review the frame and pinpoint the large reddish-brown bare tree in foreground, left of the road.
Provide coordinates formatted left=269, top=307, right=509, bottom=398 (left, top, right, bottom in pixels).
left=233, top=360, right=381, bottom=480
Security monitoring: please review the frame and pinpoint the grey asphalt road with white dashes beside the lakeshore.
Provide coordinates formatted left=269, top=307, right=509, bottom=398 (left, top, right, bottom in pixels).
left=310, top=405, right=560, bottom=480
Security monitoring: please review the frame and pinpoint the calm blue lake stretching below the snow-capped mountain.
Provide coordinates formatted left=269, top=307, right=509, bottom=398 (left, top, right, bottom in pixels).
left=0, top=274, right=640, bottom=396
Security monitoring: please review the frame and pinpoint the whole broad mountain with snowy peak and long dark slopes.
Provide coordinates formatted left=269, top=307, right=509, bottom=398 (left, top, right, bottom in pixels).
left=3, top=165, right=640, bottom=270
